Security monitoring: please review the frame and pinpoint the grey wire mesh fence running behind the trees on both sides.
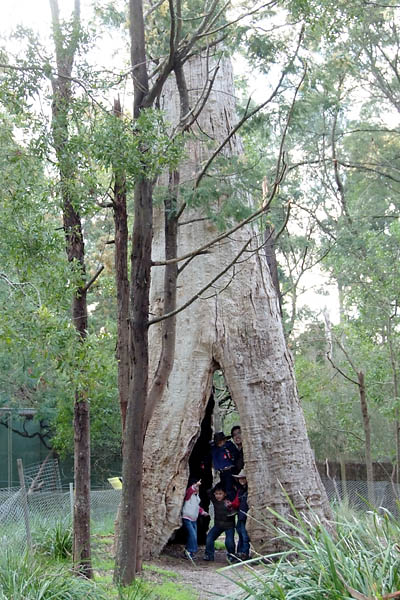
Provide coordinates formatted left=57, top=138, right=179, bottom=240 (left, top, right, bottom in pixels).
left=0, top=479, right=400, bottom=552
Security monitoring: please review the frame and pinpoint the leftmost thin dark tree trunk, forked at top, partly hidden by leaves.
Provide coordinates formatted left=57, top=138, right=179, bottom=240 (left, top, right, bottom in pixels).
left=50, top=0, right=93, bottom=578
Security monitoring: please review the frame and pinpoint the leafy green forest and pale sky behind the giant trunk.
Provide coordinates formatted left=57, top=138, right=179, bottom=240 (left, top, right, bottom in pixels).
left=0, top=0, right=400, bottom=492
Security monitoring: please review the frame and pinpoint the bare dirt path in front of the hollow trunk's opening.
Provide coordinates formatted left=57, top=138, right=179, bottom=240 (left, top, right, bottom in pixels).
left=145, top=544, right=250, bottom=600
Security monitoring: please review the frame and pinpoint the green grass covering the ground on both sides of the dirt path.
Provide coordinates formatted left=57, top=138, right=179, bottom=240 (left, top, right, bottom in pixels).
left=17, top=507, right=400, bottom=600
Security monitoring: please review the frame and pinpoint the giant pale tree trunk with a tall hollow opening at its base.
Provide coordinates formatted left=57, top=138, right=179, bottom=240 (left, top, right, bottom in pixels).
left=144, top=58, right=330, bottom=554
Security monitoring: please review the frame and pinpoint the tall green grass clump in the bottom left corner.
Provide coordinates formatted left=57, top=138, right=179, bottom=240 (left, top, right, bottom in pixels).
left=0, top=553, right=109, bottom=600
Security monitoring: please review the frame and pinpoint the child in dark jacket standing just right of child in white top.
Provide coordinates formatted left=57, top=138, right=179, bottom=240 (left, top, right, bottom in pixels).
left=204, top=483, right=235, bottom=562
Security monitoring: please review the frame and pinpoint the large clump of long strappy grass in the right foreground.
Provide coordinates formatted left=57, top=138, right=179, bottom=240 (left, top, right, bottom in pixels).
left=224, top=507, right=400, bottom=600
